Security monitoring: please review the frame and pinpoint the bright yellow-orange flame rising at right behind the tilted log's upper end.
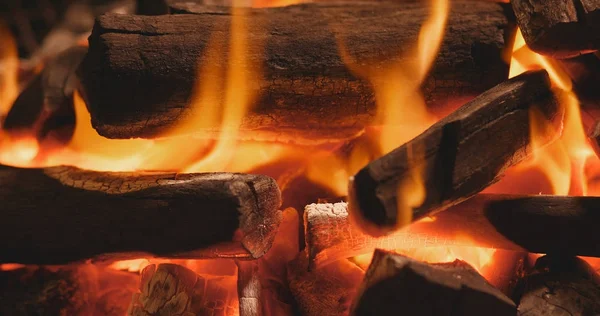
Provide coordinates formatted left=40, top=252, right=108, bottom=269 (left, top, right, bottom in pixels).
left=510, top=30, right=594, bottom=195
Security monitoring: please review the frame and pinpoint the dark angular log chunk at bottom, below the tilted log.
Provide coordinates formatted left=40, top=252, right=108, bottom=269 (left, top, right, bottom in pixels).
left=352, top=250, right=516, bottom=316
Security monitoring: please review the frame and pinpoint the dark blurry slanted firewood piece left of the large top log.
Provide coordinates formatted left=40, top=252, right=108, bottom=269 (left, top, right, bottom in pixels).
left=2, top=47, right=87, bottom=140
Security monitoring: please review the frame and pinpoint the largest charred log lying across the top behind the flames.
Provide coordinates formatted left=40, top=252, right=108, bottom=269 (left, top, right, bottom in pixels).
left=80, top=2, right=509, bottom=142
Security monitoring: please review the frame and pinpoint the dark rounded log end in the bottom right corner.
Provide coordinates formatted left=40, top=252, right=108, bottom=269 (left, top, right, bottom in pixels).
left=518, top=256, right=600, bottom=316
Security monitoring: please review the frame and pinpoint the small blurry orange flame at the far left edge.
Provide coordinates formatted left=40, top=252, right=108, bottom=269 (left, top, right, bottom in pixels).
left=0, top=23, right=19, bottom=118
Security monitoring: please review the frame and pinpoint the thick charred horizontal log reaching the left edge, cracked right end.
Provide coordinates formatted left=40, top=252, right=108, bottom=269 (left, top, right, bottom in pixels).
left=0, top=167, right=281, bottom=264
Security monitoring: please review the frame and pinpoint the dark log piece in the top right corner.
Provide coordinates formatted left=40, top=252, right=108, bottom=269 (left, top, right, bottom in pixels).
left=511, top=0, right=600, bottom=58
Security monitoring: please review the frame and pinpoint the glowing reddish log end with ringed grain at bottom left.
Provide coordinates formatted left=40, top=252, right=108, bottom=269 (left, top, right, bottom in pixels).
left=127, top=263, right=237, bottom=316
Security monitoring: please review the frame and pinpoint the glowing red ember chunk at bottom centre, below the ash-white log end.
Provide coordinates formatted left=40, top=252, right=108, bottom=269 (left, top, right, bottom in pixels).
left=288, top=251, right=364, bottom=316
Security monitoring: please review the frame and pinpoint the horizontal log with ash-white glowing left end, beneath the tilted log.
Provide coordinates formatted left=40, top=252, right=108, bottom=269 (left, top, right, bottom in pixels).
left=304, top=194, right=600, bottom=268
